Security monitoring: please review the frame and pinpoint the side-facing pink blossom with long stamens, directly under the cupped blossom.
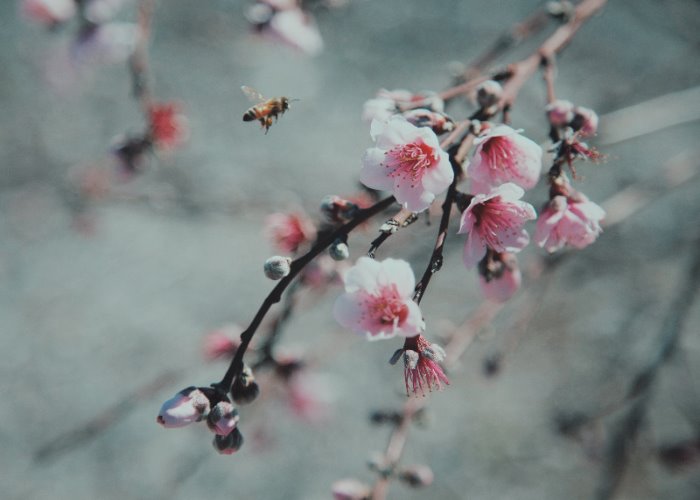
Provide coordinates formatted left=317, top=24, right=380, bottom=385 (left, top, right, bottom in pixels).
left=459, top=183, right=537, bottom=268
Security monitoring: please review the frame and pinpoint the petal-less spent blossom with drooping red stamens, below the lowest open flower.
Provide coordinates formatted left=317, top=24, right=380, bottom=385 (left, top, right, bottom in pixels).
left=390, top=335, right=450, bottom=396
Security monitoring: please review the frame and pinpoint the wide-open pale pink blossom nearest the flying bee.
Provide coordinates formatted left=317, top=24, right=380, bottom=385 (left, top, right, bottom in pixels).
left=360, top=116, right=454, bottom=212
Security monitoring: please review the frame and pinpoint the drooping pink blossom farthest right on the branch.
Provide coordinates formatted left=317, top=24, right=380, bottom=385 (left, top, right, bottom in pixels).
left=535, top=193, right=605, bottom=252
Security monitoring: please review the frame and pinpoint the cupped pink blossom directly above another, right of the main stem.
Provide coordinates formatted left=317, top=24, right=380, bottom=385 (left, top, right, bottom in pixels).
left=467, top=125, right=542, bottom=193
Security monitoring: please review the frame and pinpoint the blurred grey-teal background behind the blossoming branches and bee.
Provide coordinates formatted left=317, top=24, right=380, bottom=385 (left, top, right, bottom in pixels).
left=0, top=0, right=700, bottom=500
